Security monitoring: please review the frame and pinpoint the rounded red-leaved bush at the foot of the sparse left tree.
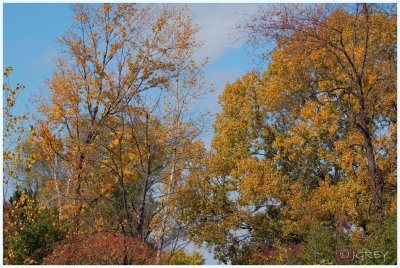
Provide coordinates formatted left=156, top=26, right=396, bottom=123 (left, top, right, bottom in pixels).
left=43, top=233, right=156, bottom=265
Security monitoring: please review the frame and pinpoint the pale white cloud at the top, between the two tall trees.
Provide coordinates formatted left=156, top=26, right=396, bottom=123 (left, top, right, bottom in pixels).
left=189, top=4, right=258, bottom=60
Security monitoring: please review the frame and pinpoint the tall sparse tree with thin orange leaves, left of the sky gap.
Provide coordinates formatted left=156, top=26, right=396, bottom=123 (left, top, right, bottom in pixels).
left=35, top=4, right=208, bottom=259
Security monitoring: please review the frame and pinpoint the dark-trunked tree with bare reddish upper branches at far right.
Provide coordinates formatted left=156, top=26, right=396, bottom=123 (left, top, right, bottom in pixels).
left=239, top=4, right=396, bottom=213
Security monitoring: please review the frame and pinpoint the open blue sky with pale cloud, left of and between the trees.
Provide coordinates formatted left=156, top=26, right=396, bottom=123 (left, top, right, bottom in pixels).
left=3, top=4, right=266, bottom=264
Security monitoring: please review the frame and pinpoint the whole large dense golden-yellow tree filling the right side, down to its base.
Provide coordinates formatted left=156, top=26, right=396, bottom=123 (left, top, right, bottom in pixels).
left=182, top=4, right=397, bottom=264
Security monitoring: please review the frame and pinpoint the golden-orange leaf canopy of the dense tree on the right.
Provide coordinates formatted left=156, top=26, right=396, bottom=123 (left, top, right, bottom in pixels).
left=195, top=5, right=396, bottom=262
